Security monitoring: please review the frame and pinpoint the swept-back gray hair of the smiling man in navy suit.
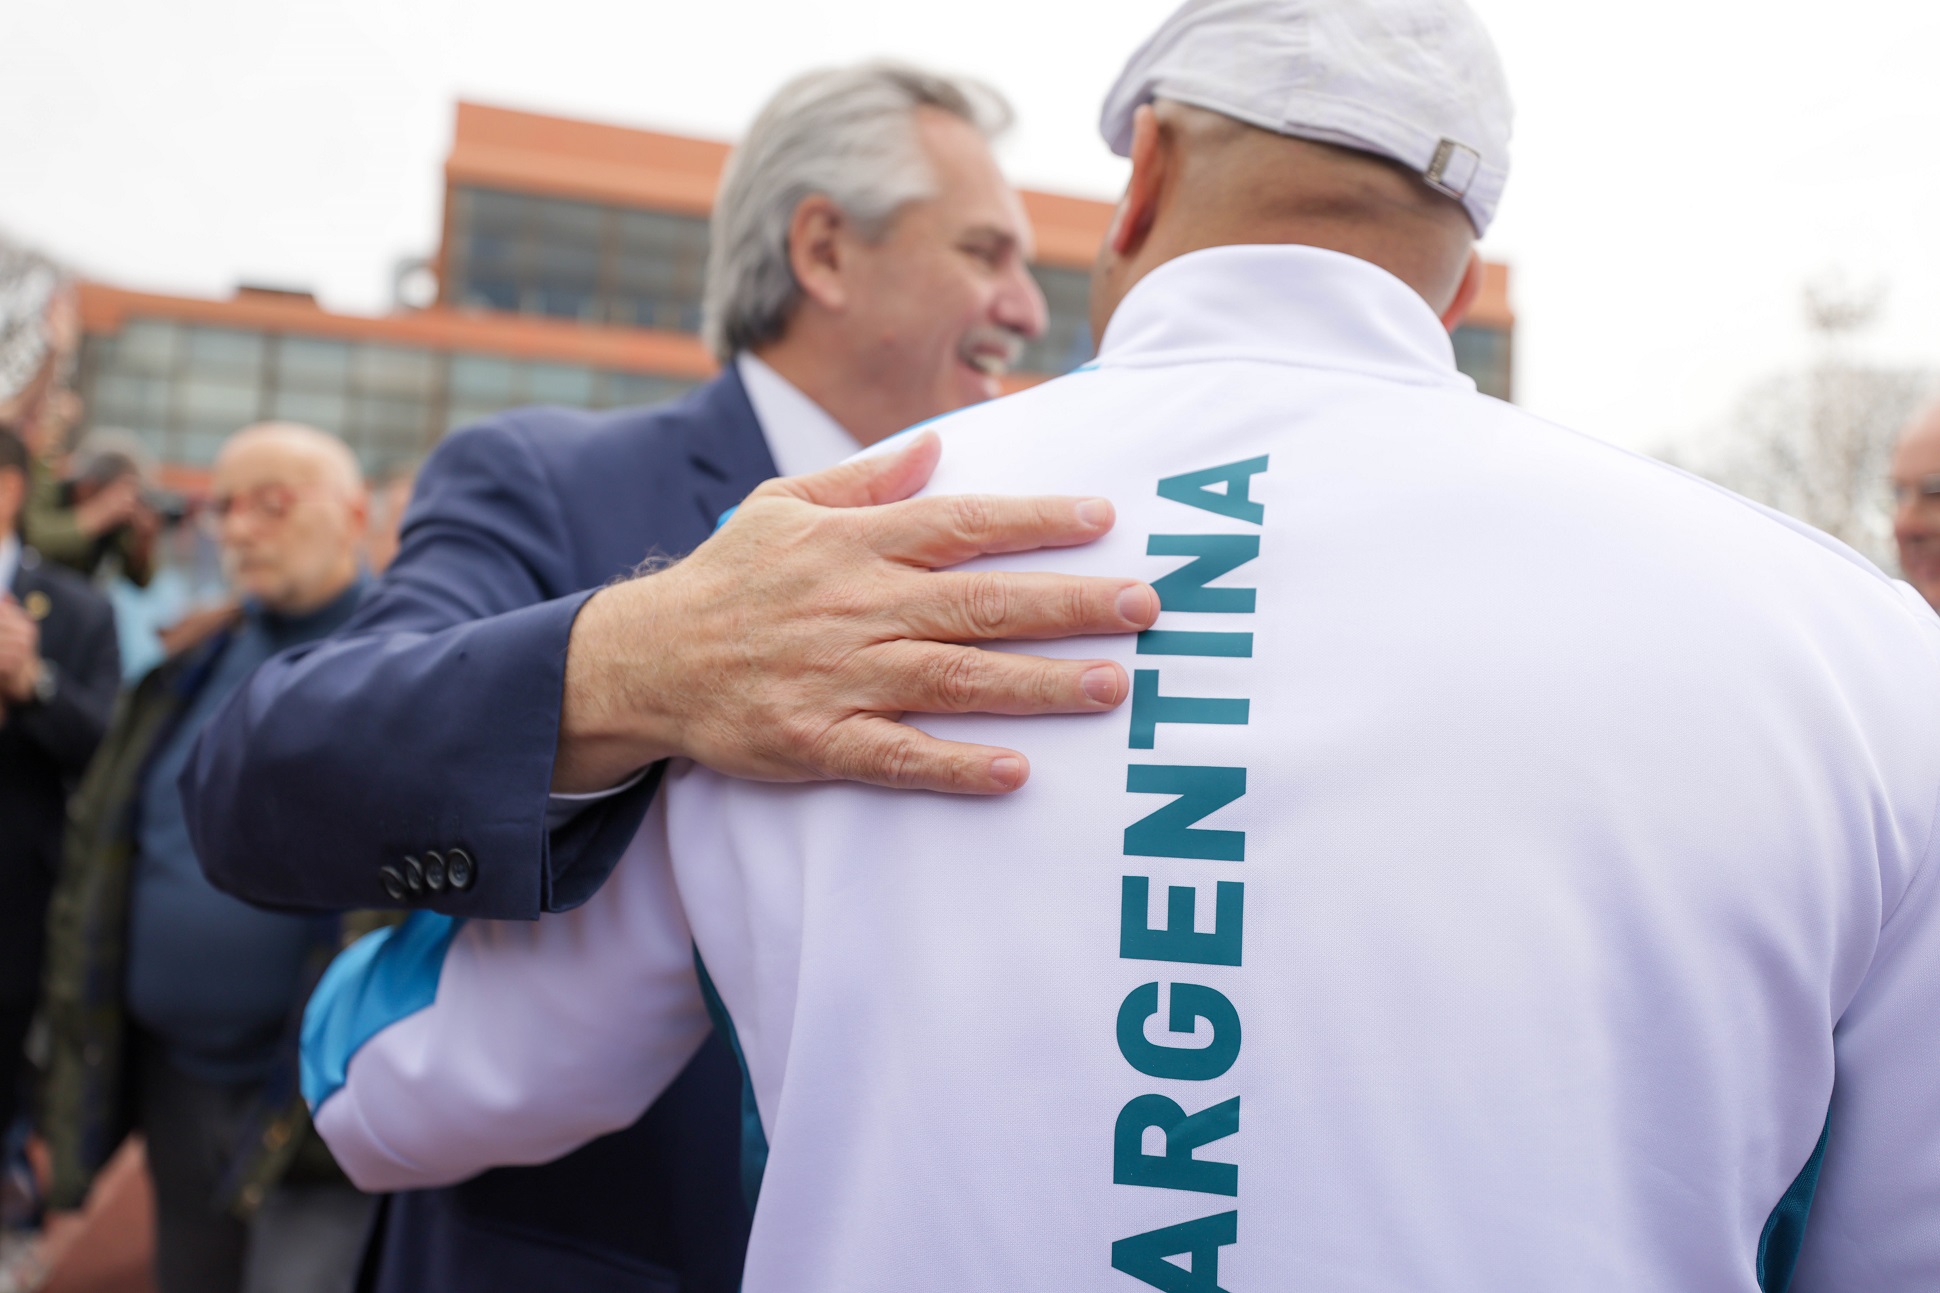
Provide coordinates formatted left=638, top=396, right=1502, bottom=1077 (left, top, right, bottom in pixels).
left=700, top=62, right=1011, bottom=363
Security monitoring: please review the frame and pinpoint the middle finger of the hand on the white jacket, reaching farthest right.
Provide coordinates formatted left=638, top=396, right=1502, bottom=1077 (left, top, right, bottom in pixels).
left=896, top=571, right=1158, bottom=643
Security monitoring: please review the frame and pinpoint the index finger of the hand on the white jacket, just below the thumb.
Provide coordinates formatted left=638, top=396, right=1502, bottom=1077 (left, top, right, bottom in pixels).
left=869, top=493, right=1116, bottom=567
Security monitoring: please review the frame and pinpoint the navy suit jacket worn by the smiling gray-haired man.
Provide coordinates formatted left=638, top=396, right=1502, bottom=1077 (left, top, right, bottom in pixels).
left=182, top=367, right=774, bottom=1293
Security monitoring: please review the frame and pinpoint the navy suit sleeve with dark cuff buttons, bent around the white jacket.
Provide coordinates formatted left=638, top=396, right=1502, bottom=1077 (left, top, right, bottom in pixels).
left=182, top=417, right=656, bottom=920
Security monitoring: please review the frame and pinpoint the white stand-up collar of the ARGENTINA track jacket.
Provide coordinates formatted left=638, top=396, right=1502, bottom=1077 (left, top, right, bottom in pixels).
left=1098, top=245, right=1474, bottom=388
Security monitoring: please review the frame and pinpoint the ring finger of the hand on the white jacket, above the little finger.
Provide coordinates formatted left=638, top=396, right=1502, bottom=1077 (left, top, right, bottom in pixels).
left=885, top=643, right=1131, bottom=714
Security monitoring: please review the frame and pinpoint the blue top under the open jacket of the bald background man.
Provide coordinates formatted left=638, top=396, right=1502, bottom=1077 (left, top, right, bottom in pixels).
left=128, top=579, right=365, bottom=1083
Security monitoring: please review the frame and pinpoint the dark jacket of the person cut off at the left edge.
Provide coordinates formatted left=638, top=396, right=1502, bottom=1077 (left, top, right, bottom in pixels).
left=0, top=547, right=120, bottom=1009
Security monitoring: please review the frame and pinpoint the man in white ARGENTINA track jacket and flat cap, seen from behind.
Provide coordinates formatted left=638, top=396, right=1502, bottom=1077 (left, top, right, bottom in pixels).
left=291, top=0, right=1940, bottom=1293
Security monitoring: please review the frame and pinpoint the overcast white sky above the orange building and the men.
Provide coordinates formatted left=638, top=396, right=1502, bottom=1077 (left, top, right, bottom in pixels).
left=0, top=0, right=1940, bottom=448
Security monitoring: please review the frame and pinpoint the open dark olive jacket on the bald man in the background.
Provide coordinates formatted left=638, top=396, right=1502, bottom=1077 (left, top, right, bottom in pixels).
left=39, top=612, right=380, bottom=1215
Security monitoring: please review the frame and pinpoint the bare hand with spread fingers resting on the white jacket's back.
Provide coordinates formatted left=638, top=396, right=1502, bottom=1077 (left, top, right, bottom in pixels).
left=553, top=435, right=1158, bottom=794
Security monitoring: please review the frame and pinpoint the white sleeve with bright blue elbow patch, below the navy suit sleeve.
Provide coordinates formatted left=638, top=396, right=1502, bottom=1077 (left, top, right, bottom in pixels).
left=303, top=796, right=710, bottom=1190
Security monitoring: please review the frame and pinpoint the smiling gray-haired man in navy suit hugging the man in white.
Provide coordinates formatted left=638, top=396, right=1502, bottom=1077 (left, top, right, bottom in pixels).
left=182, top=64, right=1158, bottom=1293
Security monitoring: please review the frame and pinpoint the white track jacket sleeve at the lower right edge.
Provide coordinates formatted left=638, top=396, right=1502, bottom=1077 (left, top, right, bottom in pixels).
left=1791, top=799, right=1940, bottom=1293
